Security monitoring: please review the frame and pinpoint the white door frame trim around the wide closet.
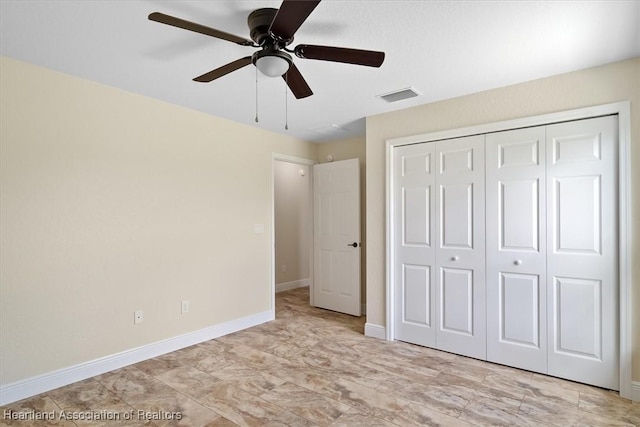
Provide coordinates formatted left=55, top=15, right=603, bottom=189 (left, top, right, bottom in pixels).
left=385, top=101, right=640, bottom=400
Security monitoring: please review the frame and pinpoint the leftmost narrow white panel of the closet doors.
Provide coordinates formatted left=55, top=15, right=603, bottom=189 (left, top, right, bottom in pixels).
left=392, top=143, right=436, bottom=347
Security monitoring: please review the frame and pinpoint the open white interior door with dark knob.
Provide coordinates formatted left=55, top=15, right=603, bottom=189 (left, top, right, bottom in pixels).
left=313, top=159, right=361, bottom=316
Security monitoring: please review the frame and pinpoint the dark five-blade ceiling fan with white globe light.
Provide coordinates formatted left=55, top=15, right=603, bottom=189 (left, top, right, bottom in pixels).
left=149, top=0, right=384, bottom=99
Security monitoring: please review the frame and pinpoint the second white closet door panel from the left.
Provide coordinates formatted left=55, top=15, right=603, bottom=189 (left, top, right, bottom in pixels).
left=435, top=135, right=486, bottom=359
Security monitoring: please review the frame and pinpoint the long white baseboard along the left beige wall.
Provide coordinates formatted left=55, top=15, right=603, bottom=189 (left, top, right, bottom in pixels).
left=0, top=310, right=275, bottom=406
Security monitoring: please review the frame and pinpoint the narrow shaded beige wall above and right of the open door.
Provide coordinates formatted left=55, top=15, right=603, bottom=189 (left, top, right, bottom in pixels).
left=318, top=137, right=367, bottom=303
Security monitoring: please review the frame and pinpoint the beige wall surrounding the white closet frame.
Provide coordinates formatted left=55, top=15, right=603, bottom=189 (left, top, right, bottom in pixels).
left=366, top=58, right=640, bottom=381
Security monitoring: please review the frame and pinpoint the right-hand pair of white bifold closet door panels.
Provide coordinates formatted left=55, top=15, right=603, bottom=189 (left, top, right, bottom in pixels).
left=486, top=117, right=619, bottom=390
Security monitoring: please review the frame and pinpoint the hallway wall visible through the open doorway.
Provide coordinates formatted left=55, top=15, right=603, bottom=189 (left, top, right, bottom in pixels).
left=273, top=161, right=313, bottom=284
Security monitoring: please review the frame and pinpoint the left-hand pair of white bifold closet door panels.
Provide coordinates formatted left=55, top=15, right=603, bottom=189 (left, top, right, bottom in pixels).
left=393, top=136, right=486, bottom=358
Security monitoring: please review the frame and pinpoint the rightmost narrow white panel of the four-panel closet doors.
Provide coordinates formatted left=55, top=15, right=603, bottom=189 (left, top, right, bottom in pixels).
left=547, top=116, right=619, bottom=390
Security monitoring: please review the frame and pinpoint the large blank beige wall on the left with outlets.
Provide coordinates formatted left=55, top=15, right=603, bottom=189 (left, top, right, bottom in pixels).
left=0, top=58, right=316, bottom=385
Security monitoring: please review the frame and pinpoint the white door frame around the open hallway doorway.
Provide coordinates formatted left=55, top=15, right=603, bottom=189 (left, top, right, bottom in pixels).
left=270, top=153, right=318, bottom=310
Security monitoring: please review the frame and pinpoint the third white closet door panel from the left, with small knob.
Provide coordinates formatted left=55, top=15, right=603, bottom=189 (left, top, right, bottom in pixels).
left=486, top=126, right=547, bottom=373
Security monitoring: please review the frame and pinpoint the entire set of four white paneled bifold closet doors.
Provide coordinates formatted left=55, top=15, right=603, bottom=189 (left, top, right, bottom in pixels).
left=392, top=116, right=619, bottom=390
